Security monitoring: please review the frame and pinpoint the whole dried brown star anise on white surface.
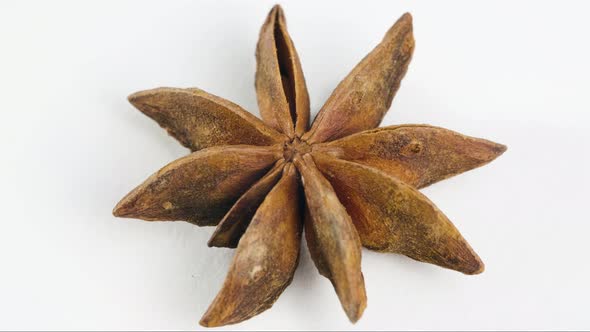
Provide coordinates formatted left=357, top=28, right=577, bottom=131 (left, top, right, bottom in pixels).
left=114, top=6, right=506, bottom=326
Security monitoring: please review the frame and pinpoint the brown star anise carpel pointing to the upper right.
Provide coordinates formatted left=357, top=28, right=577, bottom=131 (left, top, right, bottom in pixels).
left=303, top=13, right=414, bottom=143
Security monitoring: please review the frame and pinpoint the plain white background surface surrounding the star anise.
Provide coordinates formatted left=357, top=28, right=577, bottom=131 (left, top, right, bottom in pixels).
left=0, top=1, right=590, bottom=329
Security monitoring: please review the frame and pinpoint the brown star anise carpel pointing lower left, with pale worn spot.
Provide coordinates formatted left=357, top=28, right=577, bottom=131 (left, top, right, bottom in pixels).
left=201, top=165, right=302, bottom=327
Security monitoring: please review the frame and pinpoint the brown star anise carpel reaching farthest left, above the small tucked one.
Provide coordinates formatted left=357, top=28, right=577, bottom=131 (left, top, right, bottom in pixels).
left=113, top=146, right=279, bottom=226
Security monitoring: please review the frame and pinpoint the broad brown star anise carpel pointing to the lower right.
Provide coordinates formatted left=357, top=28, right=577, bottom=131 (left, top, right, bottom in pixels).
left=314, top=153, right=484, bottom=274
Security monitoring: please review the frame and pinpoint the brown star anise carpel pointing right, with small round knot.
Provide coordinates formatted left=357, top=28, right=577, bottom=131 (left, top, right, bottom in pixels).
left=314, top=125, right=506, bottom=188
